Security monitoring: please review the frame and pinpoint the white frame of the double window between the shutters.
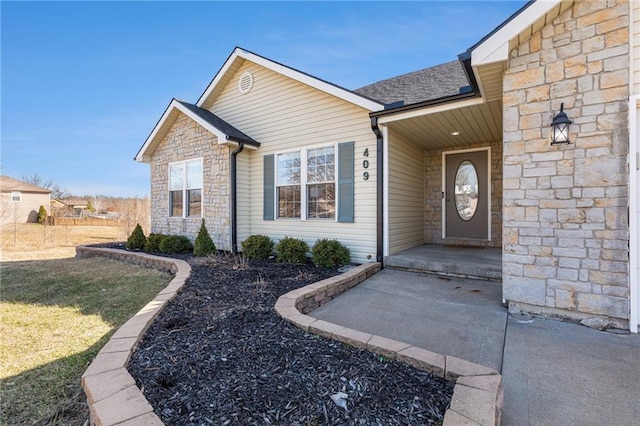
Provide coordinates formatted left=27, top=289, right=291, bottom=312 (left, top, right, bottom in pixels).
left=273, top=143, right=340, bottom=222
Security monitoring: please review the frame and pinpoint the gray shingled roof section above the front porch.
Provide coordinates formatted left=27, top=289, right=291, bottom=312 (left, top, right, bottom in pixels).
left=354, top=61, right=469, bottom=105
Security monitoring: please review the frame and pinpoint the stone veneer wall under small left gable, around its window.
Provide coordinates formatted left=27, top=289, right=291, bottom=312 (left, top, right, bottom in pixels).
left=151, top=115, right=231, bottom=250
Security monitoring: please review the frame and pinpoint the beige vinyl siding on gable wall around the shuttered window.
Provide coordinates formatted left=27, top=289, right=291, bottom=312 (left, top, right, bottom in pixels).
left=210, top=61, right=376, bottom=263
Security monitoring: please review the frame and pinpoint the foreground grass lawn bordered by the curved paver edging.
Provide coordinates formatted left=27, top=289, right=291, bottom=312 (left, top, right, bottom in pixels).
left=0, top=258, right=171, bottom=425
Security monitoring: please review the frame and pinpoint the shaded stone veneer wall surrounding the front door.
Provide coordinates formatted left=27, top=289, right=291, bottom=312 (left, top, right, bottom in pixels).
left=424, top=141, right=502, bottom=247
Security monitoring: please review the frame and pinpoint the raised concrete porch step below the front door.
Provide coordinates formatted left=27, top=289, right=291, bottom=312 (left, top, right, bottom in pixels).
left=384, top=244, right=502, bottom=281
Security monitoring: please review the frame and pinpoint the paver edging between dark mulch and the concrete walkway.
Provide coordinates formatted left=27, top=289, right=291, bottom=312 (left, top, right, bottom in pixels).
left=275, top=263, right=504, bottom=426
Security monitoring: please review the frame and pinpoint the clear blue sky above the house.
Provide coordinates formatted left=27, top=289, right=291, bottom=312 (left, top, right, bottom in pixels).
left=0, top=1, right=525, bottom=196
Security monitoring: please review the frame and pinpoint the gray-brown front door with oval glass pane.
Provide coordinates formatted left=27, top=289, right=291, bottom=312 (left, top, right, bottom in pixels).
left=443, top=149, right=491, bottom=240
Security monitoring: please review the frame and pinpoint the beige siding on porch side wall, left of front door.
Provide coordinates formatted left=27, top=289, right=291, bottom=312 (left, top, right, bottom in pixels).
left=389, top=132, right=424, bottom=254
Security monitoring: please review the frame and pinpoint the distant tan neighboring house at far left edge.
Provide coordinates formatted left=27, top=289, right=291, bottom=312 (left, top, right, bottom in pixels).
left=0, top=176, right=51, bottom=225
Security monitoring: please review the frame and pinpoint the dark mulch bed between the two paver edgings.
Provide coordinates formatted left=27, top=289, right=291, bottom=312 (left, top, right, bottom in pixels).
left=128, top=256, right=453, bottom=425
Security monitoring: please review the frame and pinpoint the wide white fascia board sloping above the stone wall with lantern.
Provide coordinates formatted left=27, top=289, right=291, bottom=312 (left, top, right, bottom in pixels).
left=471, top=0, right=562, bottom=65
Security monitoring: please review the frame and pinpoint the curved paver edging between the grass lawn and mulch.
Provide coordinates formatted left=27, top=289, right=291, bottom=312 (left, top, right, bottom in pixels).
left=76, top=246, right=191, bottom=426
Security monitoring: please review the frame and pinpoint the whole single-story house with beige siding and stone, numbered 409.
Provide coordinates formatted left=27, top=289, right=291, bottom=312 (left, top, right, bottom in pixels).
left=136, top=0, right=640, bottom=332
